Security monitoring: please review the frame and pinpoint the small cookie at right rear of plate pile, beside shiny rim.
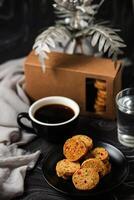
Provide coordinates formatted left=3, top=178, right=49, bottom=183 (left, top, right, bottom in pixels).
left=91, top=147, right=109, bottom=161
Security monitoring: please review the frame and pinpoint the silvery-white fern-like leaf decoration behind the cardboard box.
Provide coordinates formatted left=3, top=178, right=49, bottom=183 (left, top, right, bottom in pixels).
left=33, top=0, right=126, bottom=70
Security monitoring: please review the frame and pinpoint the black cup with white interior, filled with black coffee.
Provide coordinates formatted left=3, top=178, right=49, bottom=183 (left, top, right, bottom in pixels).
left=17, top=96, right=80, bottom=143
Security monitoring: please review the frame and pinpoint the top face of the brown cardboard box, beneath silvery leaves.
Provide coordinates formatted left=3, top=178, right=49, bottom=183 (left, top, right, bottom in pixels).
left=26, top=51, right=121, bottom=78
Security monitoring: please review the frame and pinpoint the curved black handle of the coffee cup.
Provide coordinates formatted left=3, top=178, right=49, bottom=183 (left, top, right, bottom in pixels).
left=17, top=112, right=34, bottom=133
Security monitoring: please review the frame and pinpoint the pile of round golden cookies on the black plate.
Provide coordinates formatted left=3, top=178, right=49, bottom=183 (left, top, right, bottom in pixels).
left=56, top=135, right=111, bottom=190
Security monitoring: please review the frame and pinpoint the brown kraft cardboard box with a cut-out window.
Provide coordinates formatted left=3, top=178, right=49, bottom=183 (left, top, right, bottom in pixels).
left=24, top=52, right=122, bottom=119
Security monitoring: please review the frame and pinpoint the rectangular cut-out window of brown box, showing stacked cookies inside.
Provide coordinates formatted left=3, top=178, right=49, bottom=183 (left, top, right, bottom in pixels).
left=86, top=78, right=107, bottom=114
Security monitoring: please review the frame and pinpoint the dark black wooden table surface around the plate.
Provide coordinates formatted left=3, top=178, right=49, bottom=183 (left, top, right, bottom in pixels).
left=15, top=117, right=134, bottom=200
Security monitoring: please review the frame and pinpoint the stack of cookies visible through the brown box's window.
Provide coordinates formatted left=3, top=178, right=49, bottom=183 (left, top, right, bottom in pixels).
left=94, top=80, right=107, bottom=114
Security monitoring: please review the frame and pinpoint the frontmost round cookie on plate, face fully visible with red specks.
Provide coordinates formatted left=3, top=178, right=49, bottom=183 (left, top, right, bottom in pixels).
left=72, top=168, right=99, bottom=190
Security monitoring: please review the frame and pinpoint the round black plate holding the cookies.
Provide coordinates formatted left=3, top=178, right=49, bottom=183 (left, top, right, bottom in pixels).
left=42, top=142, right=129, bottom=197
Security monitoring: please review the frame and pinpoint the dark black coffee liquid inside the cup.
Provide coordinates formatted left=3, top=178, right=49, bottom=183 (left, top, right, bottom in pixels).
left=34, top=104, right=75, bottom=124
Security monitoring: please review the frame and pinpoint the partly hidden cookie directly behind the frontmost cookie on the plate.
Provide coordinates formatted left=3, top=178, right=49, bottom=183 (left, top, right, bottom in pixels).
left=81, top=158, right=104, bottom=173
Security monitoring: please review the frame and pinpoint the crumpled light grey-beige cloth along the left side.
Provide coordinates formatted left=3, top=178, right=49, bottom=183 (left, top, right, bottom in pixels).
left=0, top=58, right=40, bottom=200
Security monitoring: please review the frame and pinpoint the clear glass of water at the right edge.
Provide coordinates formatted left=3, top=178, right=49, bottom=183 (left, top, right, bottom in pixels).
left=116, top=88, right=134, bottom=147
